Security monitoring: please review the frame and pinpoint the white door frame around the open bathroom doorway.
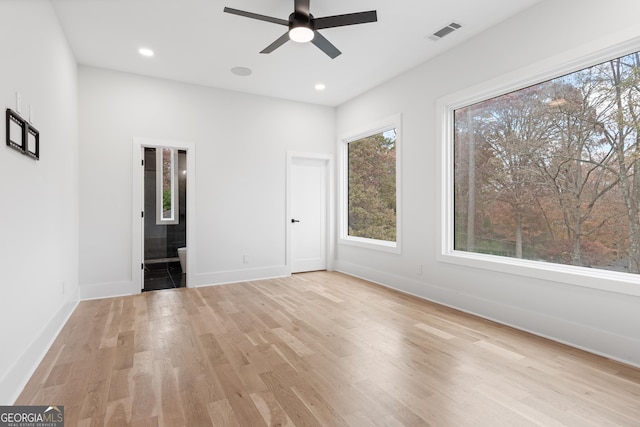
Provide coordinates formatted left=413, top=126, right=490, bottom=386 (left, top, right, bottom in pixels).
left=131, top=137, right=196, bottom=294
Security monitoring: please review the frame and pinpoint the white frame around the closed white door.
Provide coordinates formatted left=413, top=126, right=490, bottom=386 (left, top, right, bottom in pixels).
left=285, top=151, right=335, bottom=275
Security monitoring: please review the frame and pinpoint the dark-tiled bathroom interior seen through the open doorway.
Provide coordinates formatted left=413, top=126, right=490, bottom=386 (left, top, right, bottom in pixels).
left=143, top=147, right=187, bottom=292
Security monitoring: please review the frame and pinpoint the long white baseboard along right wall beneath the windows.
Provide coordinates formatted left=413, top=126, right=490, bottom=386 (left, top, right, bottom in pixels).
left=336, top=261, right=640, bottom=368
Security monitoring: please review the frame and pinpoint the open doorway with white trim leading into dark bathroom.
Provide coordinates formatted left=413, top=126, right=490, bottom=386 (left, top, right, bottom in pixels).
left=131, top=137, right=196, bottom=294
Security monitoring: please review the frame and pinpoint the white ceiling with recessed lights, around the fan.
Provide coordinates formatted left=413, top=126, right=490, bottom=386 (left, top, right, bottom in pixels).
left=51, top=0, right=541, bottom=106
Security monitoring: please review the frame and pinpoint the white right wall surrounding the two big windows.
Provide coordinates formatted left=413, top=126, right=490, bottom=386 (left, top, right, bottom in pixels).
left=336, top=0, right=640, bottom=365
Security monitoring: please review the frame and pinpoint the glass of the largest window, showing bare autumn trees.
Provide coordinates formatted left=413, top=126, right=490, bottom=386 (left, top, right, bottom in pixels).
left=448, top=48, right=640, bottom=280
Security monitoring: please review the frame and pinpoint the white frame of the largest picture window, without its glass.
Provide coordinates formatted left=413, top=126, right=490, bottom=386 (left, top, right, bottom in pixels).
left=436, top=38, right=640, bottom=296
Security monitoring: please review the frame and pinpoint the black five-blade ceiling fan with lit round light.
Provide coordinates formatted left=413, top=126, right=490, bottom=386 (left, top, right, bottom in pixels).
left=224, top=0, right=378, bottom=59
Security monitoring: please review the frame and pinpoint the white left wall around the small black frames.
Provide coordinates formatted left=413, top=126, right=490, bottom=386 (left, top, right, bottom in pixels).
left=0, top=0, right=78, bottom=405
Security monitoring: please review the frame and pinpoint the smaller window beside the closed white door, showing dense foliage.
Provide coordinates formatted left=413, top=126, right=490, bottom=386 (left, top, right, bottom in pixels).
left=341, top=115, right=399, bottom=249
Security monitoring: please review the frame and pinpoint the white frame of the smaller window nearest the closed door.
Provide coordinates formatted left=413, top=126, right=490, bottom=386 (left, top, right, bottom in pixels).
left=338, top=113, right=402, bottom=254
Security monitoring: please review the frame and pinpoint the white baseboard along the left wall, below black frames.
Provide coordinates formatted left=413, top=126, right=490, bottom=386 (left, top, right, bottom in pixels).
left=0, top=288, right=80, bottom=405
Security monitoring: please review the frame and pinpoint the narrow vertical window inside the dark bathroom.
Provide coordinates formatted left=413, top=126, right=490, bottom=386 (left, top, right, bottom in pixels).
left=156, top=148, right=179, bottom=224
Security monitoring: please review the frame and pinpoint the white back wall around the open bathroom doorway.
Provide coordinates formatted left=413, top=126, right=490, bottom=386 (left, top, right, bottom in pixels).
left=79, top=66, right=335, bottom=298
